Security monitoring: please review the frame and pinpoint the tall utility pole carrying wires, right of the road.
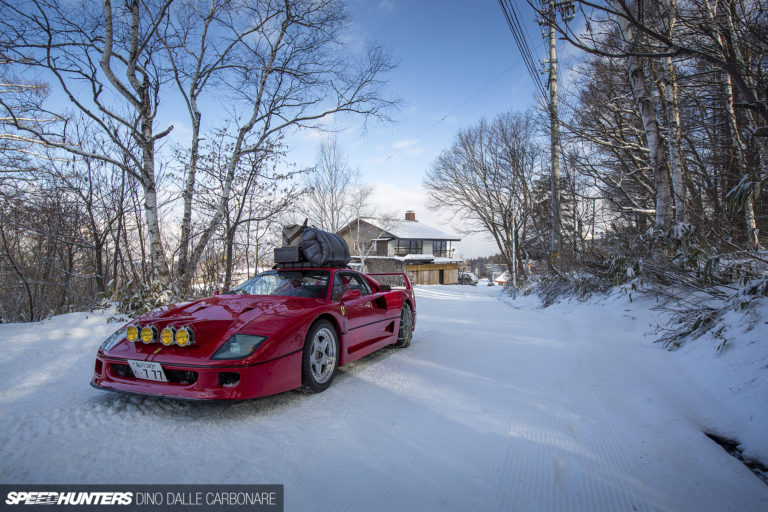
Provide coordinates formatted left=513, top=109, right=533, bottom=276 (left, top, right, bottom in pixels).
left=539, top=0, right=576, bottom=265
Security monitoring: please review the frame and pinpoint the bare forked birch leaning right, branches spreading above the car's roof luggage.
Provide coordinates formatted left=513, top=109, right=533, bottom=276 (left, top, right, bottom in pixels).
left=167, top=0, right=395, bottom=292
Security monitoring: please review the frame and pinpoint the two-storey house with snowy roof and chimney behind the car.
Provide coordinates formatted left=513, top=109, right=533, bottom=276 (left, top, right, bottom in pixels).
left=337, top=210, right=462, bottom=284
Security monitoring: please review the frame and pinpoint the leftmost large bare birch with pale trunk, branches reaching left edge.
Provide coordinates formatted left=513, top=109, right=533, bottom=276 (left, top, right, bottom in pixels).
left=0, top=0, right=172, bottom=282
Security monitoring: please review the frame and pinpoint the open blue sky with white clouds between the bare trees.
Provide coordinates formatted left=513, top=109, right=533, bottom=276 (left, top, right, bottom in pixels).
left=290, top=0, right=576, bottom=257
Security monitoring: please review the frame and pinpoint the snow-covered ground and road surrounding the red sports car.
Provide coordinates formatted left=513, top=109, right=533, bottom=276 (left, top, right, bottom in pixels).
left=0, top=286, right=768, bottom=511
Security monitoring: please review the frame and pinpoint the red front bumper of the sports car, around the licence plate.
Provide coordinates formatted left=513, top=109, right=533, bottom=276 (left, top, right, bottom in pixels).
left=91, top=350, right=302, bottom=400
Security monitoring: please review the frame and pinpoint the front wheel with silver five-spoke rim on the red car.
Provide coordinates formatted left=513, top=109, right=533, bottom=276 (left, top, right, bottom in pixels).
left=301, top=320, right=339, bottom=393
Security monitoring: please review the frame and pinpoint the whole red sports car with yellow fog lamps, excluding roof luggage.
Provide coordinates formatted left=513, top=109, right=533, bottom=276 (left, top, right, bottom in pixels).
left=91, top=268, right=416, bottom=400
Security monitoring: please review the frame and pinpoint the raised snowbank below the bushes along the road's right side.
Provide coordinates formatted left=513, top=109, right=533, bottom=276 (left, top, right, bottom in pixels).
left=500, top=285, right=768, bottom=470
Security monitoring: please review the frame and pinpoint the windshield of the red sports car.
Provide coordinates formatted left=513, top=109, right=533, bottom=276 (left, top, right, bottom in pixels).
left=232, top=269, right=330, bottom=299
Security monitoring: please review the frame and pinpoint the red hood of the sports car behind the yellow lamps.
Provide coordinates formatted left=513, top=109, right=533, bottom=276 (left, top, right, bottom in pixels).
left=107, top=295, right=323, bottom=364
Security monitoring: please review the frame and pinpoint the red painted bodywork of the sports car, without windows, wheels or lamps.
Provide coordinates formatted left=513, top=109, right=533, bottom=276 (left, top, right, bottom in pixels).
left=91, top=269, right=416, bottom=400
